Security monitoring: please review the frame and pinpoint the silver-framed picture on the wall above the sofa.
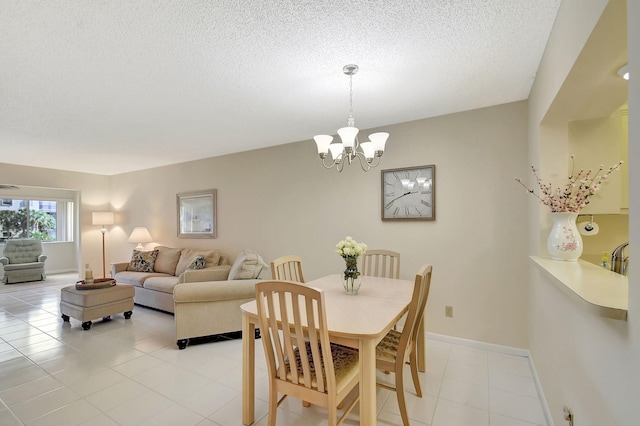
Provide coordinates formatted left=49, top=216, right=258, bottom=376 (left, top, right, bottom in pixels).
left=176, top=189, right=218, bottom=238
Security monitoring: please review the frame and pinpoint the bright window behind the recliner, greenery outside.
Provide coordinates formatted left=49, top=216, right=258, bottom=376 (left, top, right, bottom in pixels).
left=0, top=198, right=73, bottom=241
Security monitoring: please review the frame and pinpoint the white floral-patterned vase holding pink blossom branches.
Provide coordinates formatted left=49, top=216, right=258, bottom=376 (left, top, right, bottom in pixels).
left=547, top=212, right=583, bottom=262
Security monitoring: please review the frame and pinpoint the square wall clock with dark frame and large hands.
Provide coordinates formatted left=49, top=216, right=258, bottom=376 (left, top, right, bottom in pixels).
left=381, top=164, right=436, bottom=220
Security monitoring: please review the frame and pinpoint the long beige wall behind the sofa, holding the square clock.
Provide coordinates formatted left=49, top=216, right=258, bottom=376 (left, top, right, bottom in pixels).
left=109, top=102, right=527, bottom=347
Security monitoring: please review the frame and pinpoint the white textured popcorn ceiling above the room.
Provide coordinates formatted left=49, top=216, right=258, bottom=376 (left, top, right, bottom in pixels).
left=0, top=0, right=560, bottom=175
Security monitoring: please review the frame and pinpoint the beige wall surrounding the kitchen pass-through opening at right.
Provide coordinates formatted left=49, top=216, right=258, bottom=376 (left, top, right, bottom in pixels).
left=528, top=0, right=640, bottom=426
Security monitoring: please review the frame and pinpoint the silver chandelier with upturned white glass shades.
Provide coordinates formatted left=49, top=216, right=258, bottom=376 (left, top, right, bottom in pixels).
left=313, top=64, right=389, bottom=172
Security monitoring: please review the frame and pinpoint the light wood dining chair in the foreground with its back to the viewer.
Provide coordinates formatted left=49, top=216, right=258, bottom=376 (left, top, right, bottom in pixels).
left=256, top=281, right=360, bottom=426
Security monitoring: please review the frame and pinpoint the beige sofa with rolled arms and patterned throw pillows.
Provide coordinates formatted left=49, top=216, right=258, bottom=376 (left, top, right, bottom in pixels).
left=111, top=247, right=270, bottom=349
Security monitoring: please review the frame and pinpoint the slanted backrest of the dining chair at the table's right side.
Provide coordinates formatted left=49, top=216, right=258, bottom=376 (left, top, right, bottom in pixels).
left=396, top=265, right=433, bottom=362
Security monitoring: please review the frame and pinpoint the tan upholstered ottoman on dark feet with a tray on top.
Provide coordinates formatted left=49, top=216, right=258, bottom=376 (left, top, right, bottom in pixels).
left=60, top=284, right=134, bottom=330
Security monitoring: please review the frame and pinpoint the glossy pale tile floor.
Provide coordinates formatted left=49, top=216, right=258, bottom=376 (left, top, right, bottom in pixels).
left=0, top=278, right=546, bottom=426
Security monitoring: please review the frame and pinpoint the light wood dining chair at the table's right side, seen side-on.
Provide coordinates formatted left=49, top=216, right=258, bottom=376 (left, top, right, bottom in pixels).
left=376, top=265, right=433, bottom=426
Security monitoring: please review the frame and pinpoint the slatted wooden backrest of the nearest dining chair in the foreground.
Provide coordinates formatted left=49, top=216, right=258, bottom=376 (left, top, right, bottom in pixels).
left=256, top=281, right=336, bottom=397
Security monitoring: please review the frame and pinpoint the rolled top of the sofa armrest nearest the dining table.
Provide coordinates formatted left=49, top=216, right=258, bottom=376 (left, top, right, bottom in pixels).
left=173, top=280, right=260, bottom=304
